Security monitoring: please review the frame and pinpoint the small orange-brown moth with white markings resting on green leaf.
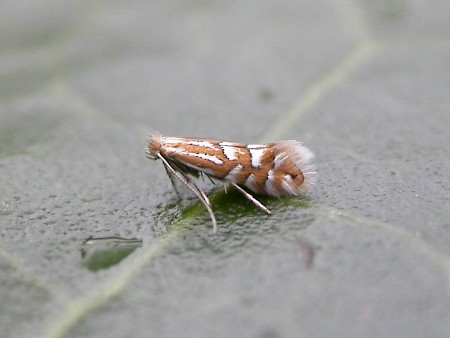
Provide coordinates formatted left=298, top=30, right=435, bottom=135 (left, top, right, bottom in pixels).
left=146, top=135, right=316, bottom=232
